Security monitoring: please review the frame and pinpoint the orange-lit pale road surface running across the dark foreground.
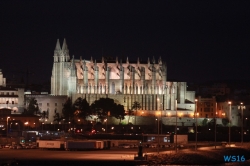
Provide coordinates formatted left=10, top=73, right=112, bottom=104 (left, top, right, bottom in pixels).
left=0, top=146, right=227, bottom=160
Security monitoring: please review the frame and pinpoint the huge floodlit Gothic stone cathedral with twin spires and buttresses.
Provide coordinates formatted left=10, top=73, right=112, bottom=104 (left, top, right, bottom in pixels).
left=51, top=39, right=195, bottom=120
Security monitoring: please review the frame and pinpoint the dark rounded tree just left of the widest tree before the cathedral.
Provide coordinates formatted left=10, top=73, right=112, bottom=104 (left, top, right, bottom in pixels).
left=73, top=97, right=92, bottom=122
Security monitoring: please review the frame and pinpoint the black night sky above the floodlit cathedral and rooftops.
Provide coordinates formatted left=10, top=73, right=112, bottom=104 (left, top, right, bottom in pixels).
left=0, top=0, right=250, bottom=83
